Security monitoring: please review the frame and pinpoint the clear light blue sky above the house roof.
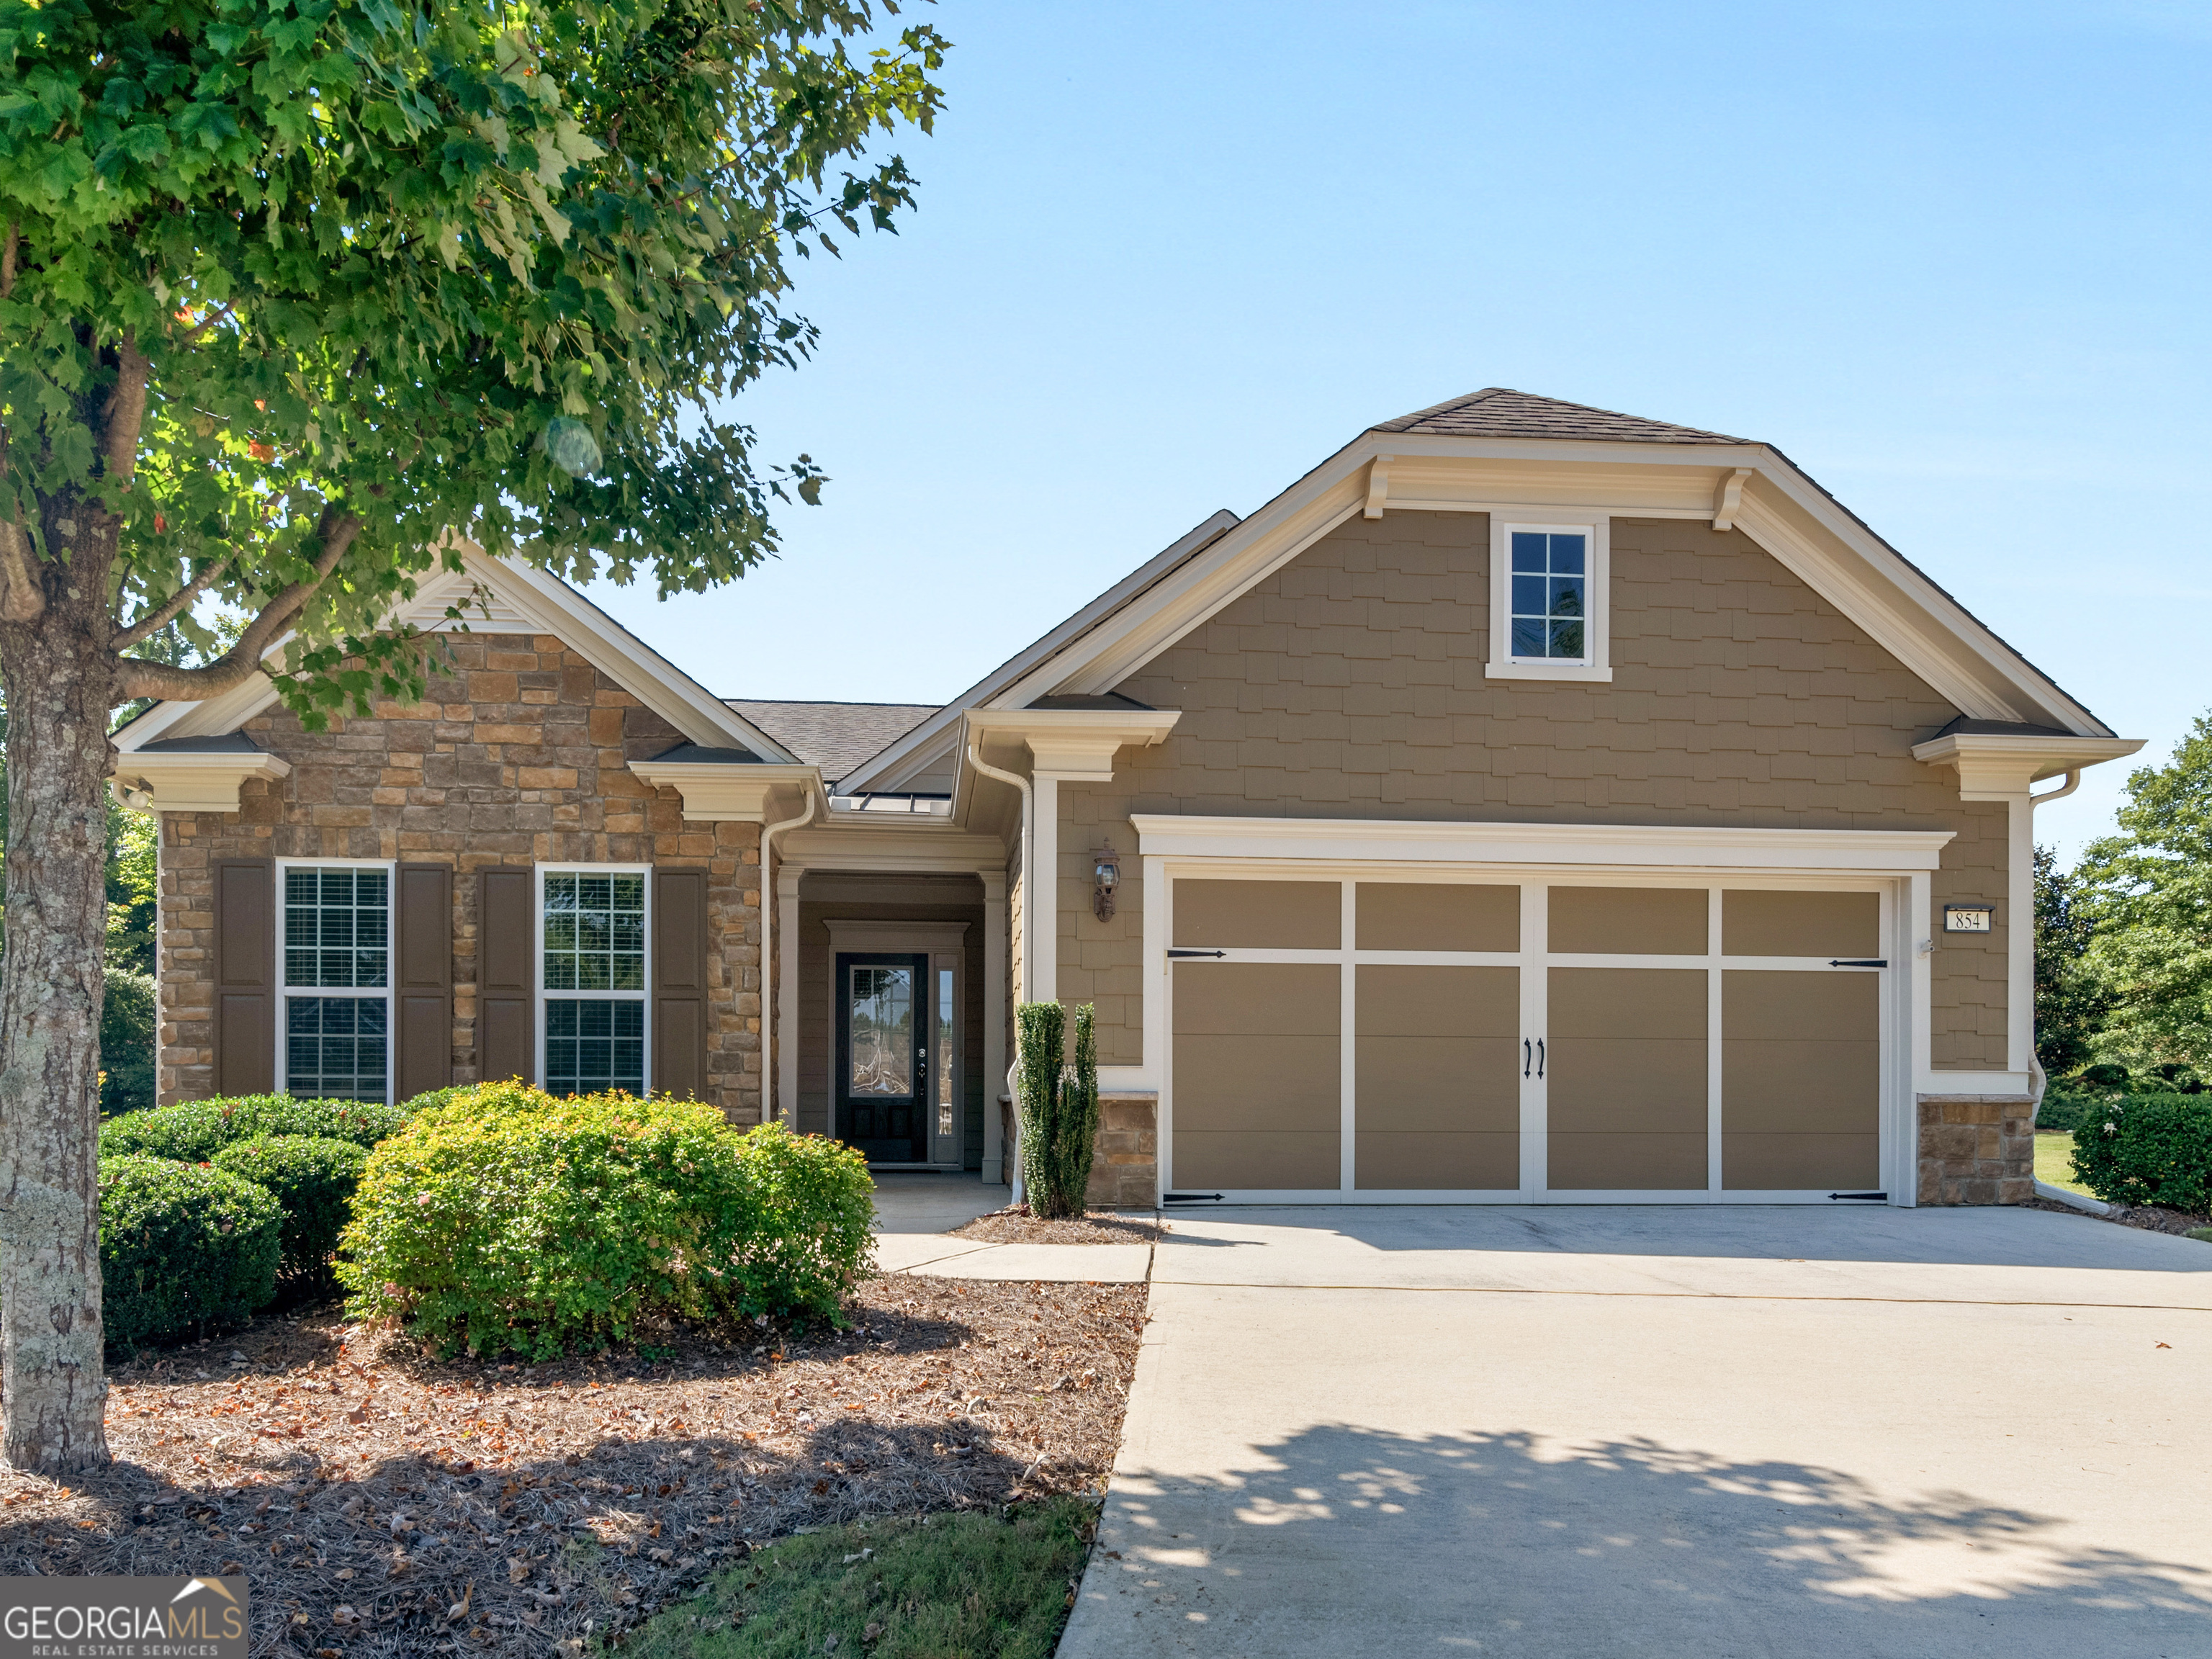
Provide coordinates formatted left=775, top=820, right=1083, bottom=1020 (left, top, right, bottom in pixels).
left=595, top=0, right=2212, bottom=852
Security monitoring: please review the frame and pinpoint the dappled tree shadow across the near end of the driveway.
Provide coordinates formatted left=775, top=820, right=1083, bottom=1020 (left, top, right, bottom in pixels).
left=1059, top=1424, right=2212, bottom=1659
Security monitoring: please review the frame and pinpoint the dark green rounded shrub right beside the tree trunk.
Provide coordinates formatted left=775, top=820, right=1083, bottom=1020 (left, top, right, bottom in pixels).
left=99, top=1153, right=283, bottom=1347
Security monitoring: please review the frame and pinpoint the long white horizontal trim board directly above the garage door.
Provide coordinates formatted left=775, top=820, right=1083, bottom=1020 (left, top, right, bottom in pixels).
left=1130, top=814, right=1956, bottom=873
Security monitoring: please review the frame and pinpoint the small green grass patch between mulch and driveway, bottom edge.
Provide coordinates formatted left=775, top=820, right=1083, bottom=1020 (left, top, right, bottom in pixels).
left=621, top=1498, right=1097, bottom=1659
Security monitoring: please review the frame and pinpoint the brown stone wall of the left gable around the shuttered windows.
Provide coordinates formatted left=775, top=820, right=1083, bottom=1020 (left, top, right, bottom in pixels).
left=159, top=635, right=761, bottom=1124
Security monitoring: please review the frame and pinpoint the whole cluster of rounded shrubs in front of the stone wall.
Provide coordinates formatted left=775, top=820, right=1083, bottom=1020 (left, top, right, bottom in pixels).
left=99, top=1084, right=873, bottom=1356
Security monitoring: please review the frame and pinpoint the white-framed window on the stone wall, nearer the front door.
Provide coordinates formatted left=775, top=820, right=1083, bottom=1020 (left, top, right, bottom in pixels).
left=537, top=865, right=646, bottom=1095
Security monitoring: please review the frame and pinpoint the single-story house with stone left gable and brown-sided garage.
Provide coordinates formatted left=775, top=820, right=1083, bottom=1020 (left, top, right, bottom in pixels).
left=115, top=390, right=2139, bottom=1205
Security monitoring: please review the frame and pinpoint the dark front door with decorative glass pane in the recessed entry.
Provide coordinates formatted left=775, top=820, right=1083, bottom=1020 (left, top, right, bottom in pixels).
left=836, top=951, right=931, bottom=1164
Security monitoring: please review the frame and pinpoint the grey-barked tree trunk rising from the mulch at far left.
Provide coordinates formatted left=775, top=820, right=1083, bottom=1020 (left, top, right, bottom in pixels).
left=0, top=500, right=117, bottom=1475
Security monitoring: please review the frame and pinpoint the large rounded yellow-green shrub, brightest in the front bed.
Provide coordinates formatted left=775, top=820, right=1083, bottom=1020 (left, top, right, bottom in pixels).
left=338, top=1084, right=873, bottom=1356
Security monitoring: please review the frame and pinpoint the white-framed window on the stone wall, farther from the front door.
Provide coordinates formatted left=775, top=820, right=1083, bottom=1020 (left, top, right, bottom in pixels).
left=276, top=863, right=392, bottom=1100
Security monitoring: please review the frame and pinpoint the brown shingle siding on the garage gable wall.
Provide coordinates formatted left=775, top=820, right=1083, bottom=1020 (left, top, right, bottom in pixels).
left=1059, top=513, right=2004, bottom=1066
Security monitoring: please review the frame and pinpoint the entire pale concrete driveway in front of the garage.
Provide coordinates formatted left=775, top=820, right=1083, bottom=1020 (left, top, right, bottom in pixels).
left=1059, top=1208, right=2212, bottom=1659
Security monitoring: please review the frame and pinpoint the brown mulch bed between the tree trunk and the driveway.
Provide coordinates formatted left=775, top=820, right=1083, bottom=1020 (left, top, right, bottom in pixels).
left=0, top=1279, right=1146, bottom=1659
